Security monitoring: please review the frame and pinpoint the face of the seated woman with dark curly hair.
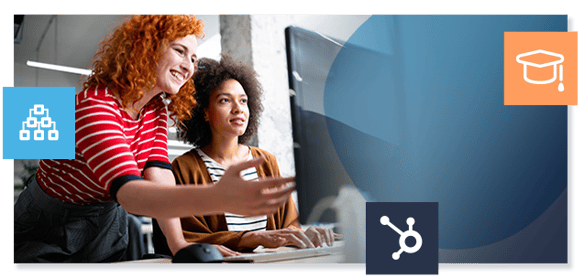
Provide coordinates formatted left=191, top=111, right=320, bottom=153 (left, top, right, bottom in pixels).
left=205, top=79, right=249, bottom=139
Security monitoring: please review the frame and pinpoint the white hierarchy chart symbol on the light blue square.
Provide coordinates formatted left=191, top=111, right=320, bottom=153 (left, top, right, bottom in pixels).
left=19, top=104, right=59, bottom=141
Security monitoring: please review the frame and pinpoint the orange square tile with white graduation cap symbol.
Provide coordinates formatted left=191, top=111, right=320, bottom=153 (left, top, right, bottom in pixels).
left=504, top=31, right=578, bottom=105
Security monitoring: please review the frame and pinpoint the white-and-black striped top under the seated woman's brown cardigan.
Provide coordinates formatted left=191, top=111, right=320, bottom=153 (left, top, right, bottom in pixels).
left=196, top=148, right=268, bottom=232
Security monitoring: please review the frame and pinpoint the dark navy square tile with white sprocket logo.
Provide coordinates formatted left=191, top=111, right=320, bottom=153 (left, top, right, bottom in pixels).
left=365, top=202, right=439, bottom=276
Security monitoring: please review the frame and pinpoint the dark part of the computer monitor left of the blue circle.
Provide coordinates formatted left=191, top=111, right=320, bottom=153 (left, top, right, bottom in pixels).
left=286, top=27, right=352, bottom=224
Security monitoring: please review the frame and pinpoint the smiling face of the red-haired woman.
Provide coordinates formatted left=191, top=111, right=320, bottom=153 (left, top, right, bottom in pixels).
left=154, top=35, right=197, bottom=95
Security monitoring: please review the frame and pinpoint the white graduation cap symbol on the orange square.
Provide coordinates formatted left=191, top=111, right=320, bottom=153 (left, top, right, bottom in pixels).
left=516, top=49, right=564, bottom=92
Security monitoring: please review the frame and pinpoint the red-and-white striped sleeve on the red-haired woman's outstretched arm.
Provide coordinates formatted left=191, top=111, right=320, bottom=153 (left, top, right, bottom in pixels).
left=75, top=90, right=141, bottom=192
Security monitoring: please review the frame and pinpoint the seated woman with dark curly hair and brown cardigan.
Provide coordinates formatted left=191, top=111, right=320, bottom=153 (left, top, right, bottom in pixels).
left=171, top=54, right=335, bottom=256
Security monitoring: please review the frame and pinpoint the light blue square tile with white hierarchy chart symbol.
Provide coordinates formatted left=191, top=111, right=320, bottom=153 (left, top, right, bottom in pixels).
left=2, top=87, right=75, bottom=159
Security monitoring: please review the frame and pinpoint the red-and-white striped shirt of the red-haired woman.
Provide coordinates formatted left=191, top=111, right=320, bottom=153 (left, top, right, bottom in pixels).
left=37, top=87, right=171, bottom=204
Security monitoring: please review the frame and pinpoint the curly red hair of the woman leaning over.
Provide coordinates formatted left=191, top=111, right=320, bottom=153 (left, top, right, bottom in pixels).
left=83, top=15, right=204, bottom=125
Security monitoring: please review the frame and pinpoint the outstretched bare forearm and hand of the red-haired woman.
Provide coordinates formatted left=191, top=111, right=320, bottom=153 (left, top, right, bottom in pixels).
left=116, top=156, right=294, bottom=218
